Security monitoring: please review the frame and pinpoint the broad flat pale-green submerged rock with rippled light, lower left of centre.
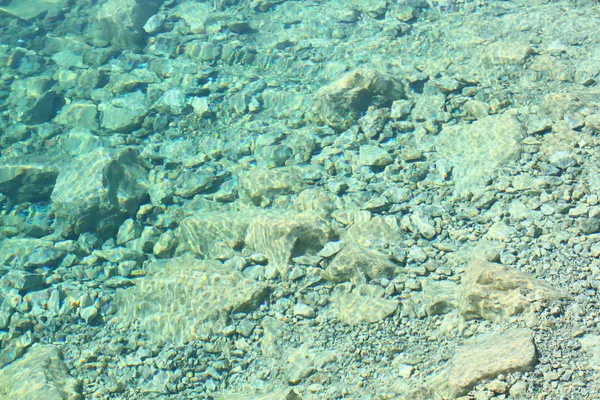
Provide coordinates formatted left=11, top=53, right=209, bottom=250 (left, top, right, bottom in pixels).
left=115, top=258, right=267, bottom=344
